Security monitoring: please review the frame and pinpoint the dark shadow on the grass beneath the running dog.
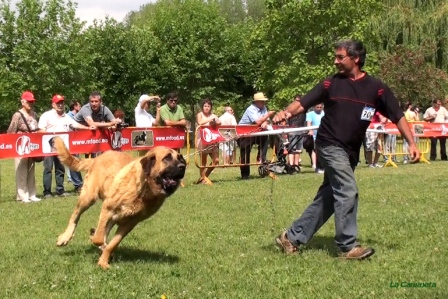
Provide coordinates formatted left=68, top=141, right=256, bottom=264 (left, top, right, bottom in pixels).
left=61, top=246, right=179, bottom=264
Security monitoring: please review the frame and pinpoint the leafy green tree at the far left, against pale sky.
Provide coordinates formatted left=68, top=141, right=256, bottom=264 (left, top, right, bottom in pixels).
left=0, top=0, right=89, bottom=130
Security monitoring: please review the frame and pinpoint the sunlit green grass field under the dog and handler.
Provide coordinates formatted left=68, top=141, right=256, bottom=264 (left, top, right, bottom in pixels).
left=0, top=152, right=448, bottom=299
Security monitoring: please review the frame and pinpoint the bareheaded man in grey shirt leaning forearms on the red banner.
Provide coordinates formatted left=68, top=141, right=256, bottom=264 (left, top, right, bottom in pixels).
left=75, top=91, right=121, bottom=158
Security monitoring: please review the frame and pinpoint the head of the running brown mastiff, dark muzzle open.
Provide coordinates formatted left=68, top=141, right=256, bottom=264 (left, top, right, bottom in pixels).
left=140, top=146, right=186, bottom=196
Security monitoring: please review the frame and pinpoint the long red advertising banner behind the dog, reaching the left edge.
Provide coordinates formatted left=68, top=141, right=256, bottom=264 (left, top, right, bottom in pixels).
left=0, top=127, right=186, bottom=159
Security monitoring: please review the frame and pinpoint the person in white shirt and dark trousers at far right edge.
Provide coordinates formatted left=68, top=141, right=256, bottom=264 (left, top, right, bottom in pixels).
left=423, top=100, right=448, bottom=161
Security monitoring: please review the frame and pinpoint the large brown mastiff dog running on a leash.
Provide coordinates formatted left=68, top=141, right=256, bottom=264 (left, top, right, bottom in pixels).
left=54, top=137, right=186, bottom=268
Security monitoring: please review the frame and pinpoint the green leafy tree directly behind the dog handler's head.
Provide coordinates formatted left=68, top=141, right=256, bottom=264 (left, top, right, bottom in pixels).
left=253, top=0, right=378, bottom=109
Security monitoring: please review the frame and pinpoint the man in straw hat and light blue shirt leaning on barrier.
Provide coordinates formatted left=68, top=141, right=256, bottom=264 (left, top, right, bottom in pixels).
left=238, top=92, right=275, bottom=180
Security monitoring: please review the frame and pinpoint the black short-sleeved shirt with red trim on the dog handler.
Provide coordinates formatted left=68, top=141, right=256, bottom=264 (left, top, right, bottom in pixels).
left=300, top=74, right=404, bottom=163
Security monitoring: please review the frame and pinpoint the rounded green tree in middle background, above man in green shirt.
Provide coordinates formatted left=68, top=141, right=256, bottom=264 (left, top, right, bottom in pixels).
left=126, top=0, right=256, bottom=117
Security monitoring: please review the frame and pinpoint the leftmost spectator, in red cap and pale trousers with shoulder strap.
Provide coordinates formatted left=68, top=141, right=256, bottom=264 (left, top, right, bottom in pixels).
left=6, top=91, right=40, bottom=203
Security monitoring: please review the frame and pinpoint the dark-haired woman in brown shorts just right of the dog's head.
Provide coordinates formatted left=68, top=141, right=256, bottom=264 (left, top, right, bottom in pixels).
left=196, top=98, right=221, bottom=185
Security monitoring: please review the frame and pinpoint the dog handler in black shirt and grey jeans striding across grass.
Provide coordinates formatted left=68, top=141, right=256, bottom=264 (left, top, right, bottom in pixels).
left=273, top=40, right=420, bottom=260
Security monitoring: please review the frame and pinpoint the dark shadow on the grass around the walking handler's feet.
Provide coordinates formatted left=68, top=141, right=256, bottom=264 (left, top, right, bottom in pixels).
left=262, top=236, right=388, bottom=257
